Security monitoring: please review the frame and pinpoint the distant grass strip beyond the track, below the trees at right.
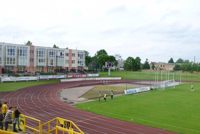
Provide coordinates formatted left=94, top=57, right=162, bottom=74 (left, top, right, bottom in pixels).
left=100, top=71, right=200, bottom=81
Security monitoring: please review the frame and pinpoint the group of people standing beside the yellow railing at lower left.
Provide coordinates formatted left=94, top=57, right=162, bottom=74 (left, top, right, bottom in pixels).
left=0, top=102, right=22, bottom=132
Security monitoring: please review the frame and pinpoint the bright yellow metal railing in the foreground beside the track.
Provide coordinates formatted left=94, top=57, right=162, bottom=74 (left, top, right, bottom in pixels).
left=0, top=114, right=84, bottom=134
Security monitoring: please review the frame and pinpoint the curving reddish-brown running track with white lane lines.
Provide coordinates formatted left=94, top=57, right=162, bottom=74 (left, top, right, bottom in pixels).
left=0, top=81, right=173, bottom=134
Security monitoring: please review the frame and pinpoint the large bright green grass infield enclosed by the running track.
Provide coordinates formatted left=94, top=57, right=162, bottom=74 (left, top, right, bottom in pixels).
left=76, top=84, right=200, bottom=134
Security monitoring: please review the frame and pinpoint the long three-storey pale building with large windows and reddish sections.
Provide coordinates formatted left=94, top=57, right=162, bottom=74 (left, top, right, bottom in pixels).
left=0, top=42, right=85, bottom=74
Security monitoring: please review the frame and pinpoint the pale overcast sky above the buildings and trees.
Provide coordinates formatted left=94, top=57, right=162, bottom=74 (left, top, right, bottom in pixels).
left=0, top=0, right=200, bottom=62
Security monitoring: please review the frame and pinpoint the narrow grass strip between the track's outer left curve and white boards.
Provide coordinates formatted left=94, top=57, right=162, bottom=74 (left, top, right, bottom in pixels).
left=0, top=80, right=59, bottom=92
